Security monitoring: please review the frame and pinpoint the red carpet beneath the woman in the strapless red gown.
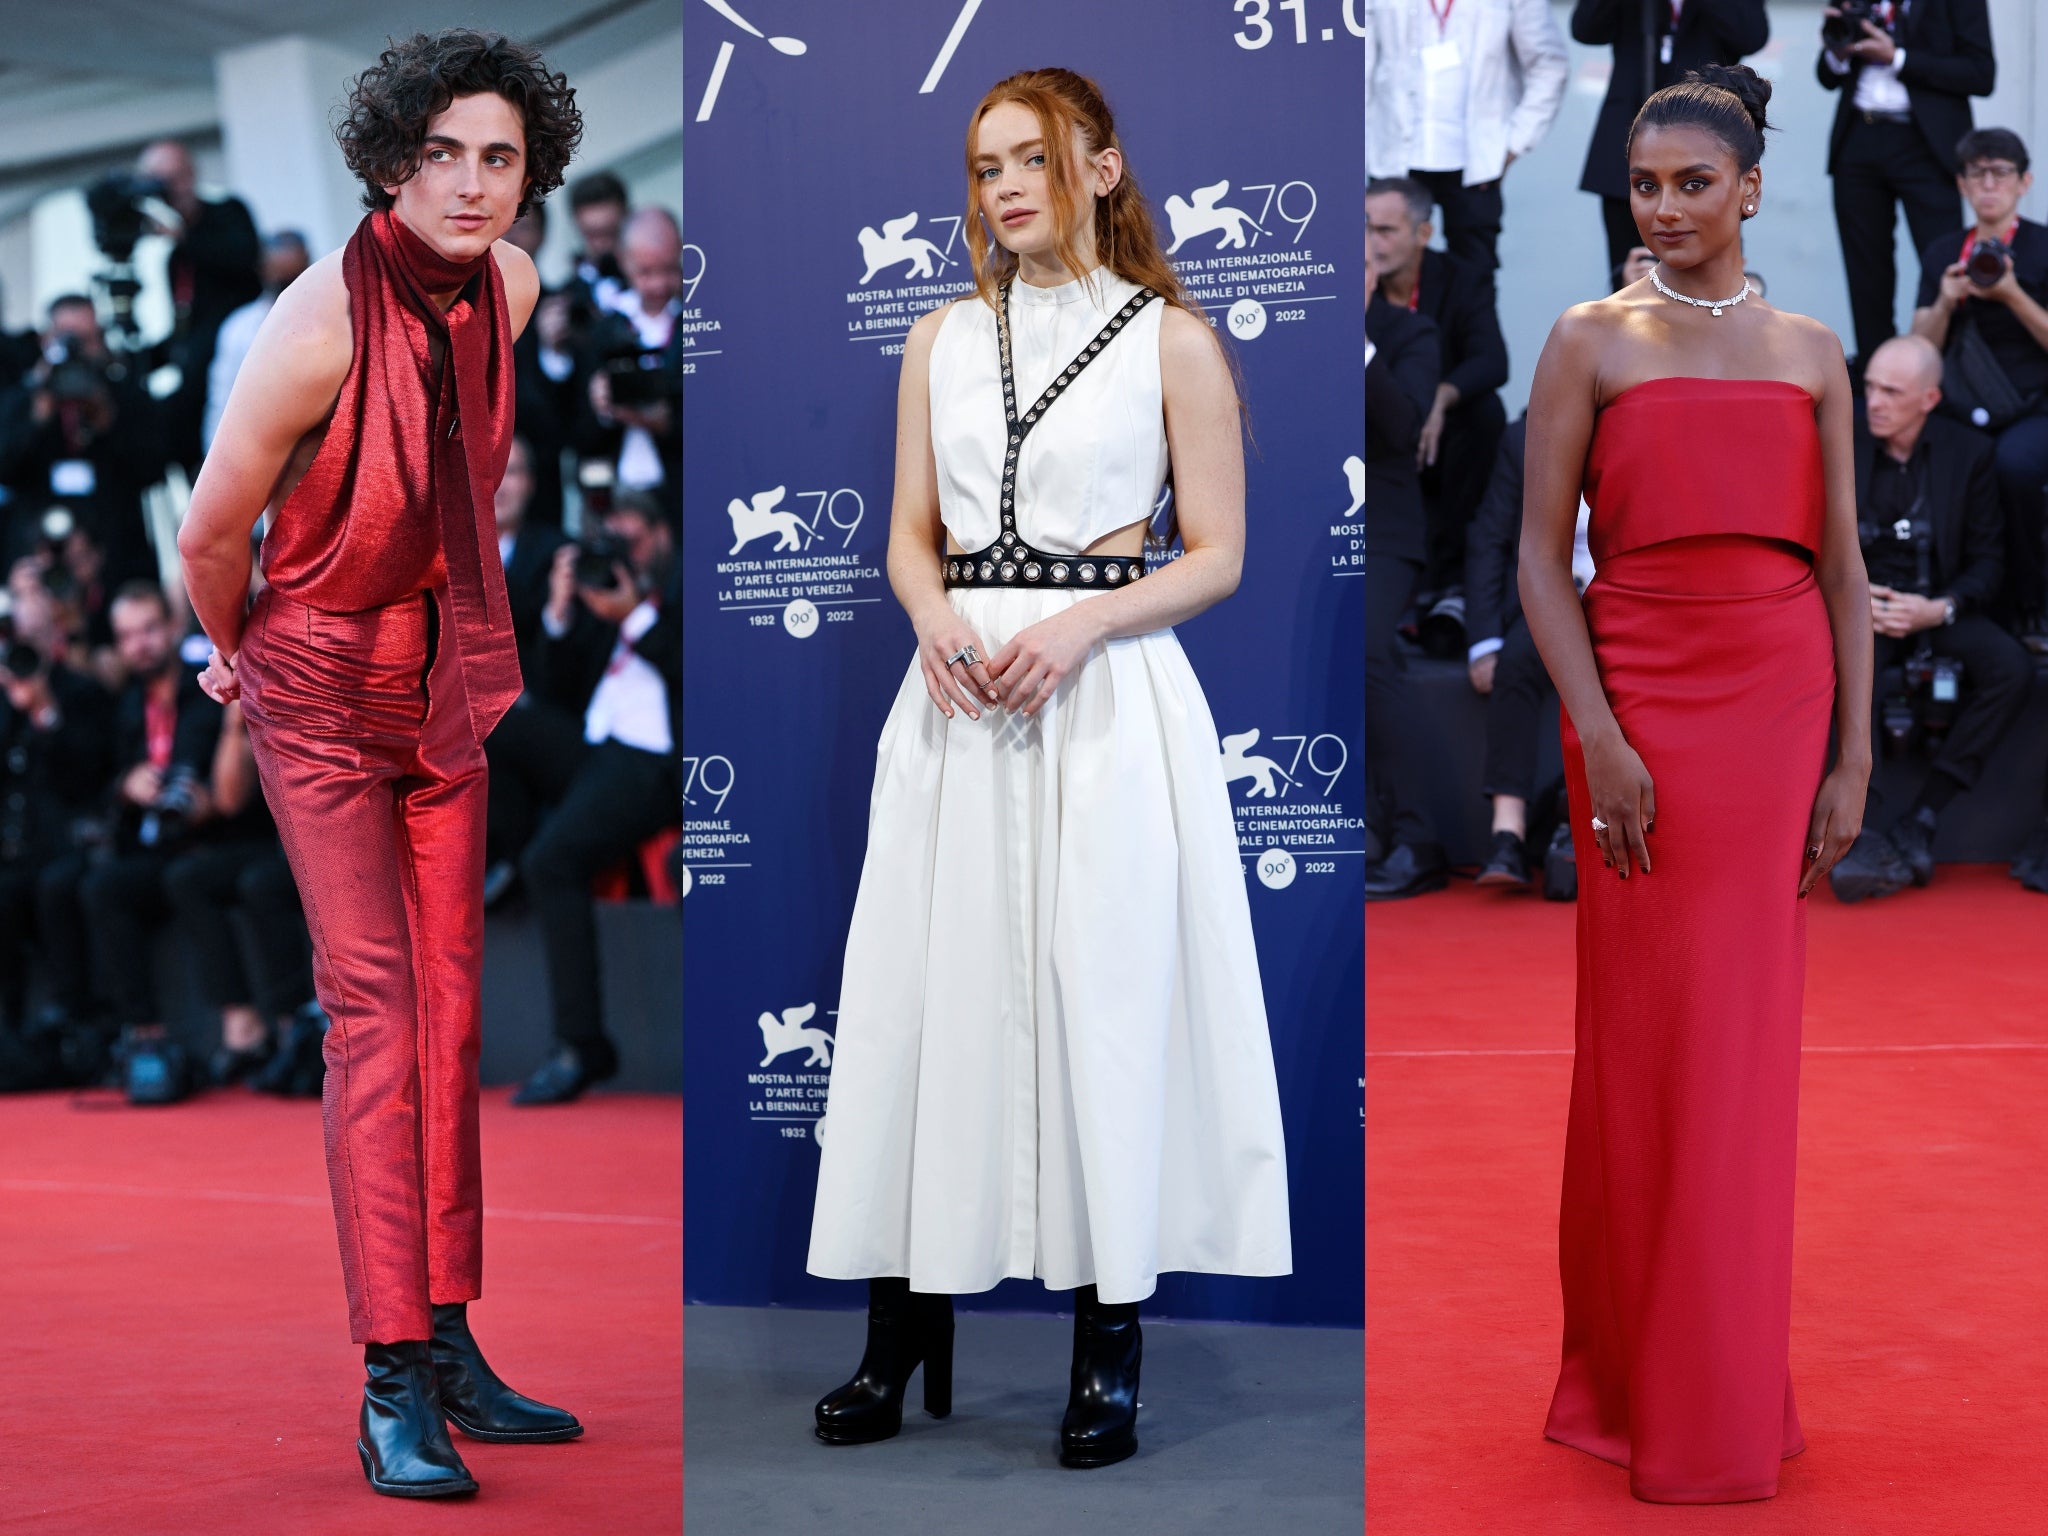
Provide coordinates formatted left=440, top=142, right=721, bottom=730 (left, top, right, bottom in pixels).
left=1366, top=864, right=2048, bottom=1536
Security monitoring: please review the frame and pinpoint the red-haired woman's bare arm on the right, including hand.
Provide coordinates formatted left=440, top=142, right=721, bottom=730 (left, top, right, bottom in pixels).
left=989, top=307, right=1245, bottom=715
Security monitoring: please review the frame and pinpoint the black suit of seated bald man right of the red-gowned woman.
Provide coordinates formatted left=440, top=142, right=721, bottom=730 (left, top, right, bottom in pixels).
left=1855, top=410, right=2034, bottom=788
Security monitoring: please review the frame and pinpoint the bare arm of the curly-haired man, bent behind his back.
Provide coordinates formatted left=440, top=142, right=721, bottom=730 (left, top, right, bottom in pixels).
left=178, top=254, right=352, bottom=702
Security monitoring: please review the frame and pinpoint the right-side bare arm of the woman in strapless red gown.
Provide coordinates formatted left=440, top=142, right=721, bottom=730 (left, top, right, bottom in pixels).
left=1798, top=322, right=1876, bottom=895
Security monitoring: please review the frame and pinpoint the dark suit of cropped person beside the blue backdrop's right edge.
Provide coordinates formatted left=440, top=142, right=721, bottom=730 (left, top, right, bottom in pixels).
left=1366, top=295, right=1440, bottom=848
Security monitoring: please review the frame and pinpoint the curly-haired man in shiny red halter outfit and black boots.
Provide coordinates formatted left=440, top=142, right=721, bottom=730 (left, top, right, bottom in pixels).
left=178, top=29, right=582, bottom=1499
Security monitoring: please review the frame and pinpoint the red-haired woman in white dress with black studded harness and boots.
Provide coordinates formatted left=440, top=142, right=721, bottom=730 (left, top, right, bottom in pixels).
left=809, top=70, right=1290, bottom=1466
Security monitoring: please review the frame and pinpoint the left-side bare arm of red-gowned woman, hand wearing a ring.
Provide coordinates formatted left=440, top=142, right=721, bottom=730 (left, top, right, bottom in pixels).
left=1520, top=305, right=1657, bottom=881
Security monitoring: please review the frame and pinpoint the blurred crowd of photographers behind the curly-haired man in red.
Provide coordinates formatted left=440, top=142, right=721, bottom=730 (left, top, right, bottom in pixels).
left=0, top=141, right=682, bottom=1104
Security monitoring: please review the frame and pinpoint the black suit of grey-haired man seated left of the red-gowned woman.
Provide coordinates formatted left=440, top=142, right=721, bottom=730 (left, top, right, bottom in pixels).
left=1415, top=250, right=1507, bottom=592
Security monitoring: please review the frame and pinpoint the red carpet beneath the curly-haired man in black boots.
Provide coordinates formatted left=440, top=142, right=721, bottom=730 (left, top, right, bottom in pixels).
left=0, top=1090, right=682, bottom=1536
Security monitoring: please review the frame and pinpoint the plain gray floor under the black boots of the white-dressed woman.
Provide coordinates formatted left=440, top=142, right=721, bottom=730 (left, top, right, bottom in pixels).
left=684, top=1307, right=1364, bottom=1536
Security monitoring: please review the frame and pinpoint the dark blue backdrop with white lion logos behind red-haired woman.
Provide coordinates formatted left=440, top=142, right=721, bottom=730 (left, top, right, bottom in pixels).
left=684, top=0, right=1364, bottom=1325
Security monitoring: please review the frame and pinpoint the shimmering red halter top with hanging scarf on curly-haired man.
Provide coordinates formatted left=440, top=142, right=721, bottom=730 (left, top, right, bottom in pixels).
left=264, top=209, right=520, bottom=741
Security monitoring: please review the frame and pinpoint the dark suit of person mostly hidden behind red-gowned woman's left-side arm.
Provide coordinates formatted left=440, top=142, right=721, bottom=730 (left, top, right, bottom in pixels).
left=1464, top=416, right=1556, bottom=801
